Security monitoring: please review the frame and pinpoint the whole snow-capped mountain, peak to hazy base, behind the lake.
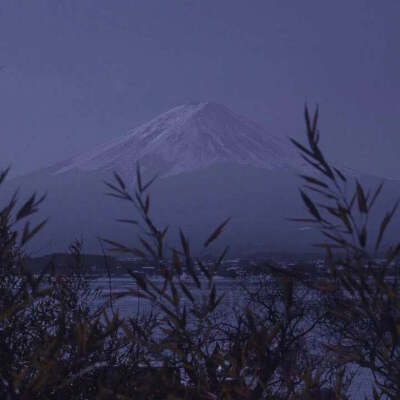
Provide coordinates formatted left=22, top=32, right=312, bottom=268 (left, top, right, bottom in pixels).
left=1, top=102, right=400, bottom=255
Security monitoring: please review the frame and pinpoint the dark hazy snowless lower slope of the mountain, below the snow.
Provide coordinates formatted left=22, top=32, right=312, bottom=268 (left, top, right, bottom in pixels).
left=1, top=163, right=312, bottom=255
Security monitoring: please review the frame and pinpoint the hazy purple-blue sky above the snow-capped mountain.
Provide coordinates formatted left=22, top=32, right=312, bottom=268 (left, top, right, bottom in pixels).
left=0, top=0, right=400, bottom=177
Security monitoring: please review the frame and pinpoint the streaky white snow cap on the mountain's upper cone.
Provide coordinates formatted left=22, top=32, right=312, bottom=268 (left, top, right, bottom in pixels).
left=55, top=102, right=299, bottom=176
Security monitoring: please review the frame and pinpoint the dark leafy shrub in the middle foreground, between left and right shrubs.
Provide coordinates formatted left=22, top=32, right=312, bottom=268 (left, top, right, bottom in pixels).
left=100, top=161, right=348, bottom=399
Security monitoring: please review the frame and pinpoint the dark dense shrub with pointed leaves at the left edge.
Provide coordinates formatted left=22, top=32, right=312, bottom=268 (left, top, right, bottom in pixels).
left=0, top=175, right=120, bottom=399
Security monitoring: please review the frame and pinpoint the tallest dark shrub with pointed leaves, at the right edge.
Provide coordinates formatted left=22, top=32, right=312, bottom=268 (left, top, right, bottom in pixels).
left=286, top=108, right=400, bottom=399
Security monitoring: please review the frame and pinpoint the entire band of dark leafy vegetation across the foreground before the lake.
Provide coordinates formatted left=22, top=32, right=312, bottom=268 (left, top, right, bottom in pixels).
left=0, top=110, right=400, bottom=400
